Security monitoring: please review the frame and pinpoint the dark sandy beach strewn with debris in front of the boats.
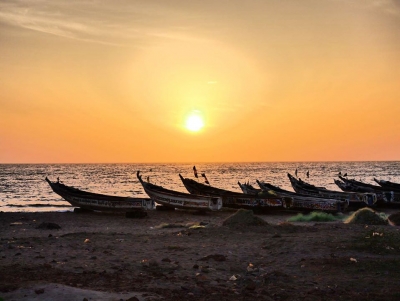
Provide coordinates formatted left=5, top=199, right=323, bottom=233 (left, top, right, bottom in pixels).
left=0, top=209, right=400, bottom=301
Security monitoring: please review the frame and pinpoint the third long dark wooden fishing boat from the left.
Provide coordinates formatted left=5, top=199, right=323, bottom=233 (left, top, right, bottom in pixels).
left=179, top=174, right=293, bottom=210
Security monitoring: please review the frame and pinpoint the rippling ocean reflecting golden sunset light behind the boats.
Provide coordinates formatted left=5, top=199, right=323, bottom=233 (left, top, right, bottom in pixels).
left=0, top=161, right=400, bottom=212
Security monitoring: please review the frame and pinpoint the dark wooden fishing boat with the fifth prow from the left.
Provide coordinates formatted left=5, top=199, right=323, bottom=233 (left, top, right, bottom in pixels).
left=257, top=180, right=349, bottom=213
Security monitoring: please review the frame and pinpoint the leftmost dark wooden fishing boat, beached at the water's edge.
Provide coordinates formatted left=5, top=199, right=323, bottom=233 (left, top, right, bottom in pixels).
left=45, top=177, right=154, bottom=217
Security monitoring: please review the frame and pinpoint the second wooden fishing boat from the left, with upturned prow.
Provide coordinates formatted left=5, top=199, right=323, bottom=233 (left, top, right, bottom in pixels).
left=136, top=171, right=222, bottom=211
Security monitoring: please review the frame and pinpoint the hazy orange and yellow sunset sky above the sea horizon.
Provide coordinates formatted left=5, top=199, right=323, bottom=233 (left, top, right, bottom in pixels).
left=0, top=0, right=400, bottom=163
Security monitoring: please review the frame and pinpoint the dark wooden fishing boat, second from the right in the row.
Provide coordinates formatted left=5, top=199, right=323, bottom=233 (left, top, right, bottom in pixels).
left=335, top=176, right=400, bottom=204
